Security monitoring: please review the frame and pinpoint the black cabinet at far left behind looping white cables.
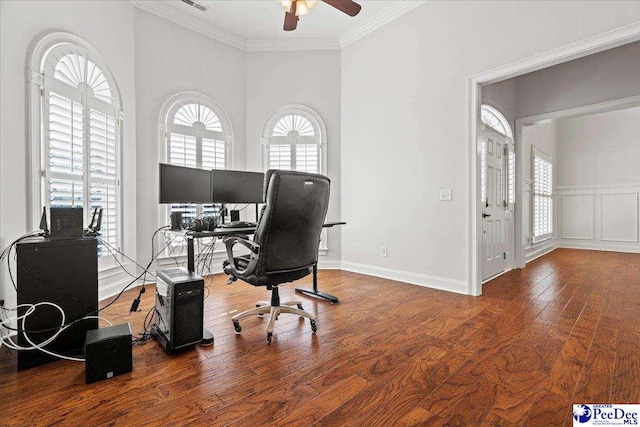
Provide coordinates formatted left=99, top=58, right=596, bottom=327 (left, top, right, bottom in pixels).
left=16, top=238, right=98, bottom=370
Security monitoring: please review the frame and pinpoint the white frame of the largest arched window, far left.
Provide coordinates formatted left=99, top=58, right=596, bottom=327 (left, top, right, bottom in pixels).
left=27, top=32, right=124, bottom=260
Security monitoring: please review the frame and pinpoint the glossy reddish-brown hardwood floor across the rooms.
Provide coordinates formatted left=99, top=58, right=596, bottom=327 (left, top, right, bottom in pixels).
left=0, top=249, right=640, bottom=426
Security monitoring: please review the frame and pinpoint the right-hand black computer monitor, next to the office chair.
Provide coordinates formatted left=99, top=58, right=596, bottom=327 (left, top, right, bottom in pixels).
left=211, top=170, right=264, bottom=203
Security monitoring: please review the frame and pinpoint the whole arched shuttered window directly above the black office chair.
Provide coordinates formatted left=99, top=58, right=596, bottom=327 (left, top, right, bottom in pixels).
left=263, top=105, right=326, bottom=173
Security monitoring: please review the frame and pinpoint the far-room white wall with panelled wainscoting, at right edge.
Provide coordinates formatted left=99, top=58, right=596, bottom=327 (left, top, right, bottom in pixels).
left=557, top=107, right=640, bottom=252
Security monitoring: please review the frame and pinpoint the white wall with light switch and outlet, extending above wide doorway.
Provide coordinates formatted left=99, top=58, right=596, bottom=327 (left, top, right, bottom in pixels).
left=342, top=1, right=640, bottom=291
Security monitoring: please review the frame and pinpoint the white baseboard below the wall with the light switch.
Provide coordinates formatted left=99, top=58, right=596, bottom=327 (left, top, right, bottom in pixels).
left=341, top=261, right=469, bottom=295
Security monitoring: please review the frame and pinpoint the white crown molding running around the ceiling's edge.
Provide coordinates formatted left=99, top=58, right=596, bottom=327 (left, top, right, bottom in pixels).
left=129, top=0, right=427, bottom=52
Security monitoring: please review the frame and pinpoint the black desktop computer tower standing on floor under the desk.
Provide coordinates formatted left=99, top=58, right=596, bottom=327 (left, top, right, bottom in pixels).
left=151, top=267, right=204, bottom=351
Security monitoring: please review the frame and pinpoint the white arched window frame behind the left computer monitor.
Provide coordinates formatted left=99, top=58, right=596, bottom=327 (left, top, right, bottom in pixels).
left=158, top=91, right=233, bottom=224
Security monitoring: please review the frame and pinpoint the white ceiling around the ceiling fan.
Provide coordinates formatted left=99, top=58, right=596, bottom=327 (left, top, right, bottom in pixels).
left=130, top=0, right=425, bottom=51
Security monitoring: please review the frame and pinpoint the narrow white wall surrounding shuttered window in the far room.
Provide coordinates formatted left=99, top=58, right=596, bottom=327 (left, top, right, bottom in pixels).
left=520, top=122, right=558, bottom=261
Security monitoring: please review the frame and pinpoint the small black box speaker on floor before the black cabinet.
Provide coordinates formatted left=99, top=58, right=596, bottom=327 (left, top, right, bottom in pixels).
left=84, top=323, right=133, bottom=384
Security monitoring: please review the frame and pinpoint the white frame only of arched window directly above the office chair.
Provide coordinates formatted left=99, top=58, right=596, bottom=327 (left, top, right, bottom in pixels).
left=262, top=104, right=327, bottom=175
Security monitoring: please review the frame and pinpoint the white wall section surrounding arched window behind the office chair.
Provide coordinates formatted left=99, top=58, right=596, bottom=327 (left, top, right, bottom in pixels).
left=247, top=50, right=342, bottom=268
